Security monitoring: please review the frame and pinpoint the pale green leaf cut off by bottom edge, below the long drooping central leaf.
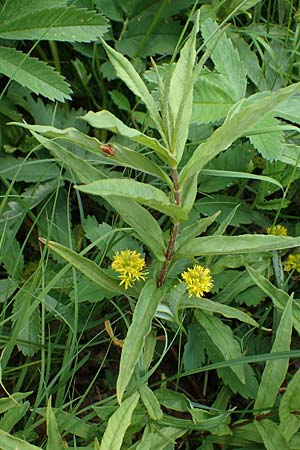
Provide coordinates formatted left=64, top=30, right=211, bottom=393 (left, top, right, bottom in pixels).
left=101, top=392, right=139, bottom=450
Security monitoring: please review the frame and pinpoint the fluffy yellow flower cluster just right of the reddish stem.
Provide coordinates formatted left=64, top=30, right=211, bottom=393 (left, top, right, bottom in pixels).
left=181, top=264, right=213, bottom=297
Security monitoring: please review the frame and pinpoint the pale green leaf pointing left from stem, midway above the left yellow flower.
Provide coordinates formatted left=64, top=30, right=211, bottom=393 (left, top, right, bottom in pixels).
left=75, top=178, right=187, bottom=221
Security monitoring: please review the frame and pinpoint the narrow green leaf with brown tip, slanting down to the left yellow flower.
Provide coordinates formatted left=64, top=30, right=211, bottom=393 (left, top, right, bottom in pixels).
left=40, top=239, right=125, bottom=294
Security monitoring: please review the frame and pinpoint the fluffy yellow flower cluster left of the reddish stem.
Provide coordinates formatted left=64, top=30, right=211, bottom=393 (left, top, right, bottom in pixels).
left=111, top=250, right=147, bottom=289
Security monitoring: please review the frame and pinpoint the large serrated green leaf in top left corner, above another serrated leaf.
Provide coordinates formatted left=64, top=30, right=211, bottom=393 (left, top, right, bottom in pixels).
left=0, top=6, right=108, bottom=42
